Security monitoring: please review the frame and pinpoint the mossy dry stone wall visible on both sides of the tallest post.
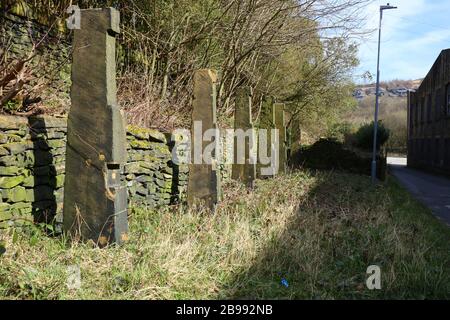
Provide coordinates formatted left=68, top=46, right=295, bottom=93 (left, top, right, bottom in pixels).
left=0, top=116, right=188, bottom=228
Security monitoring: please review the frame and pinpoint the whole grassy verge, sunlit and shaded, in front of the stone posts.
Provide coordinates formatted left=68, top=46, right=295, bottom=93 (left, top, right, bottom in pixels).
left=0, top=171, right=450, bottom=299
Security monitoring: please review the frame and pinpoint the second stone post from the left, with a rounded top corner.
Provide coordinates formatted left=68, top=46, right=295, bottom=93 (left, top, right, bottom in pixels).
left=187, top=69, right=221, bottom=210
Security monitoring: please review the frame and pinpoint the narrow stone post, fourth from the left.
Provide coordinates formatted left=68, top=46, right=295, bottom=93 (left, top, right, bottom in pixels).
left=256, top=97, right=275, bottom=179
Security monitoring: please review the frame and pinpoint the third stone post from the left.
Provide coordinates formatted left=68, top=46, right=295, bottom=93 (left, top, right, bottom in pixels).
left=232, top=88, right=256, bottom=188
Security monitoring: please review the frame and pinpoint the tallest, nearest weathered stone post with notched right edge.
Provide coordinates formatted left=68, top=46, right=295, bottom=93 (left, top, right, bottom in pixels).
left=63, top=8, right=128, bottom=246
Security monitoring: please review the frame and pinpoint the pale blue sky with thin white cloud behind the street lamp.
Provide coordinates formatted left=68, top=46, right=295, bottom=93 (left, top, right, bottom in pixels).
left=354, top=0, right=450, bottom=83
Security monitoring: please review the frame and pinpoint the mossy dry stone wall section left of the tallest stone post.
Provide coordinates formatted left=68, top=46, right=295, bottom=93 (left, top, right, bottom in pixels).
left=0, top=116, right=66, bottom=226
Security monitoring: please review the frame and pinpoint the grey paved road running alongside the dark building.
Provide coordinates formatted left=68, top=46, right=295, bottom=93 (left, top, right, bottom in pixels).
left=387, top=158, right=450, bottom=226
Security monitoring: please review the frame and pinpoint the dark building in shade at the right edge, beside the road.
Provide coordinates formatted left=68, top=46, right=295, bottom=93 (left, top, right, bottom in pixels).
left=408, top=49, right=450, bottom=173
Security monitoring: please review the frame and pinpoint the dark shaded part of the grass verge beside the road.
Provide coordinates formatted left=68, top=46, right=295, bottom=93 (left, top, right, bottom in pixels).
left=218, top=173, right=450, bottom=299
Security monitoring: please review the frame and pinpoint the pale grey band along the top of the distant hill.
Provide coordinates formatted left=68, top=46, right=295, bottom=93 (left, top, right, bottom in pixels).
left=353, top=79, right=423, bottom=100
